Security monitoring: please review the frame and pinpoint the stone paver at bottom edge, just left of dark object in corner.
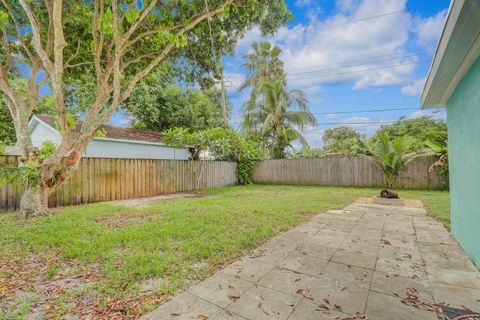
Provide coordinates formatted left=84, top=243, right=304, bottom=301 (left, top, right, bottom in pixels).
left=365, top=291, right=438, bottom=320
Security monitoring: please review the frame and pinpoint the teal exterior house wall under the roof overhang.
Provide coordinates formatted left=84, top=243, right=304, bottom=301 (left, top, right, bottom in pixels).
left=447, top=58, right=480, bottom=267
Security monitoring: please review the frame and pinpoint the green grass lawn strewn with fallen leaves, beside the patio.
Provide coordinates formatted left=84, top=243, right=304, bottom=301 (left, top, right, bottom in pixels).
left=0, top=186, right=449, bottom=318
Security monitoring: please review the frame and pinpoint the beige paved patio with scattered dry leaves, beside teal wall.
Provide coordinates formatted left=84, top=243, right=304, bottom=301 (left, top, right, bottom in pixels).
left=144, top=203, right=480, bottom=320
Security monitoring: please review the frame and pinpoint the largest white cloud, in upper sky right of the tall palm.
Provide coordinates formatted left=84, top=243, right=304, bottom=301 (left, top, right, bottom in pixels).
left=238, top=0, right=417, bottom=94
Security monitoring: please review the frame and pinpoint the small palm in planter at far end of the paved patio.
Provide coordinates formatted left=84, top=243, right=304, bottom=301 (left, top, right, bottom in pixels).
left=361, top=130, right=424, bottom=190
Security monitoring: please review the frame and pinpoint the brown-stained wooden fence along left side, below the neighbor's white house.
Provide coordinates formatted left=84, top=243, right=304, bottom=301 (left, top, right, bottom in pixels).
left=0, top=156, right=237, bottom=210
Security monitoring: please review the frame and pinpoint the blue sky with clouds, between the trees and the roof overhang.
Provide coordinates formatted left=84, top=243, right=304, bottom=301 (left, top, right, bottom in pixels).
left=112, top=0, right=450, bottom=146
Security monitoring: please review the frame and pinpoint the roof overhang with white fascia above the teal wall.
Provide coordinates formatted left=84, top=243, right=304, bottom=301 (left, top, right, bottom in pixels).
left=421, top=0, right=480, bottom=108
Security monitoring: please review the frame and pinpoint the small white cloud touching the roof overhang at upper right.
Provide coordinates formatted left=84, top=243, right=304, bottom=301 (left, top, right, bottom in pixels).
left=414, top=9, right=448, bottom=53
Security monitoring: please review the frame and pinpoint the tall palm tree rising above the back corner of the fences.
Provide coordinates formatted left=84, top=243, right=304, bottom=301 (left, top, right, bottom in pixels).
left=252, top=75, right=317, bottom=158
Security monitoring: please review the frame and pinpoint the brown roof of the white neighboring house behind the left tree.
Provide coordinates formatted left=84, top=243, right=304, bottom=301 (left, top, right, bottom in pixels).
left=34, top=115, right=161, bottom=143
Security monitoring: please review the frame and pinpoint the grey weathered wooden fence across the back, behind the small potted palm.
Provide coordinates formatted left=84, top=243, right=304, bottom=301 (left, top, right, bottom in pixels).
left=252, top=156, right=447, bottom=190
